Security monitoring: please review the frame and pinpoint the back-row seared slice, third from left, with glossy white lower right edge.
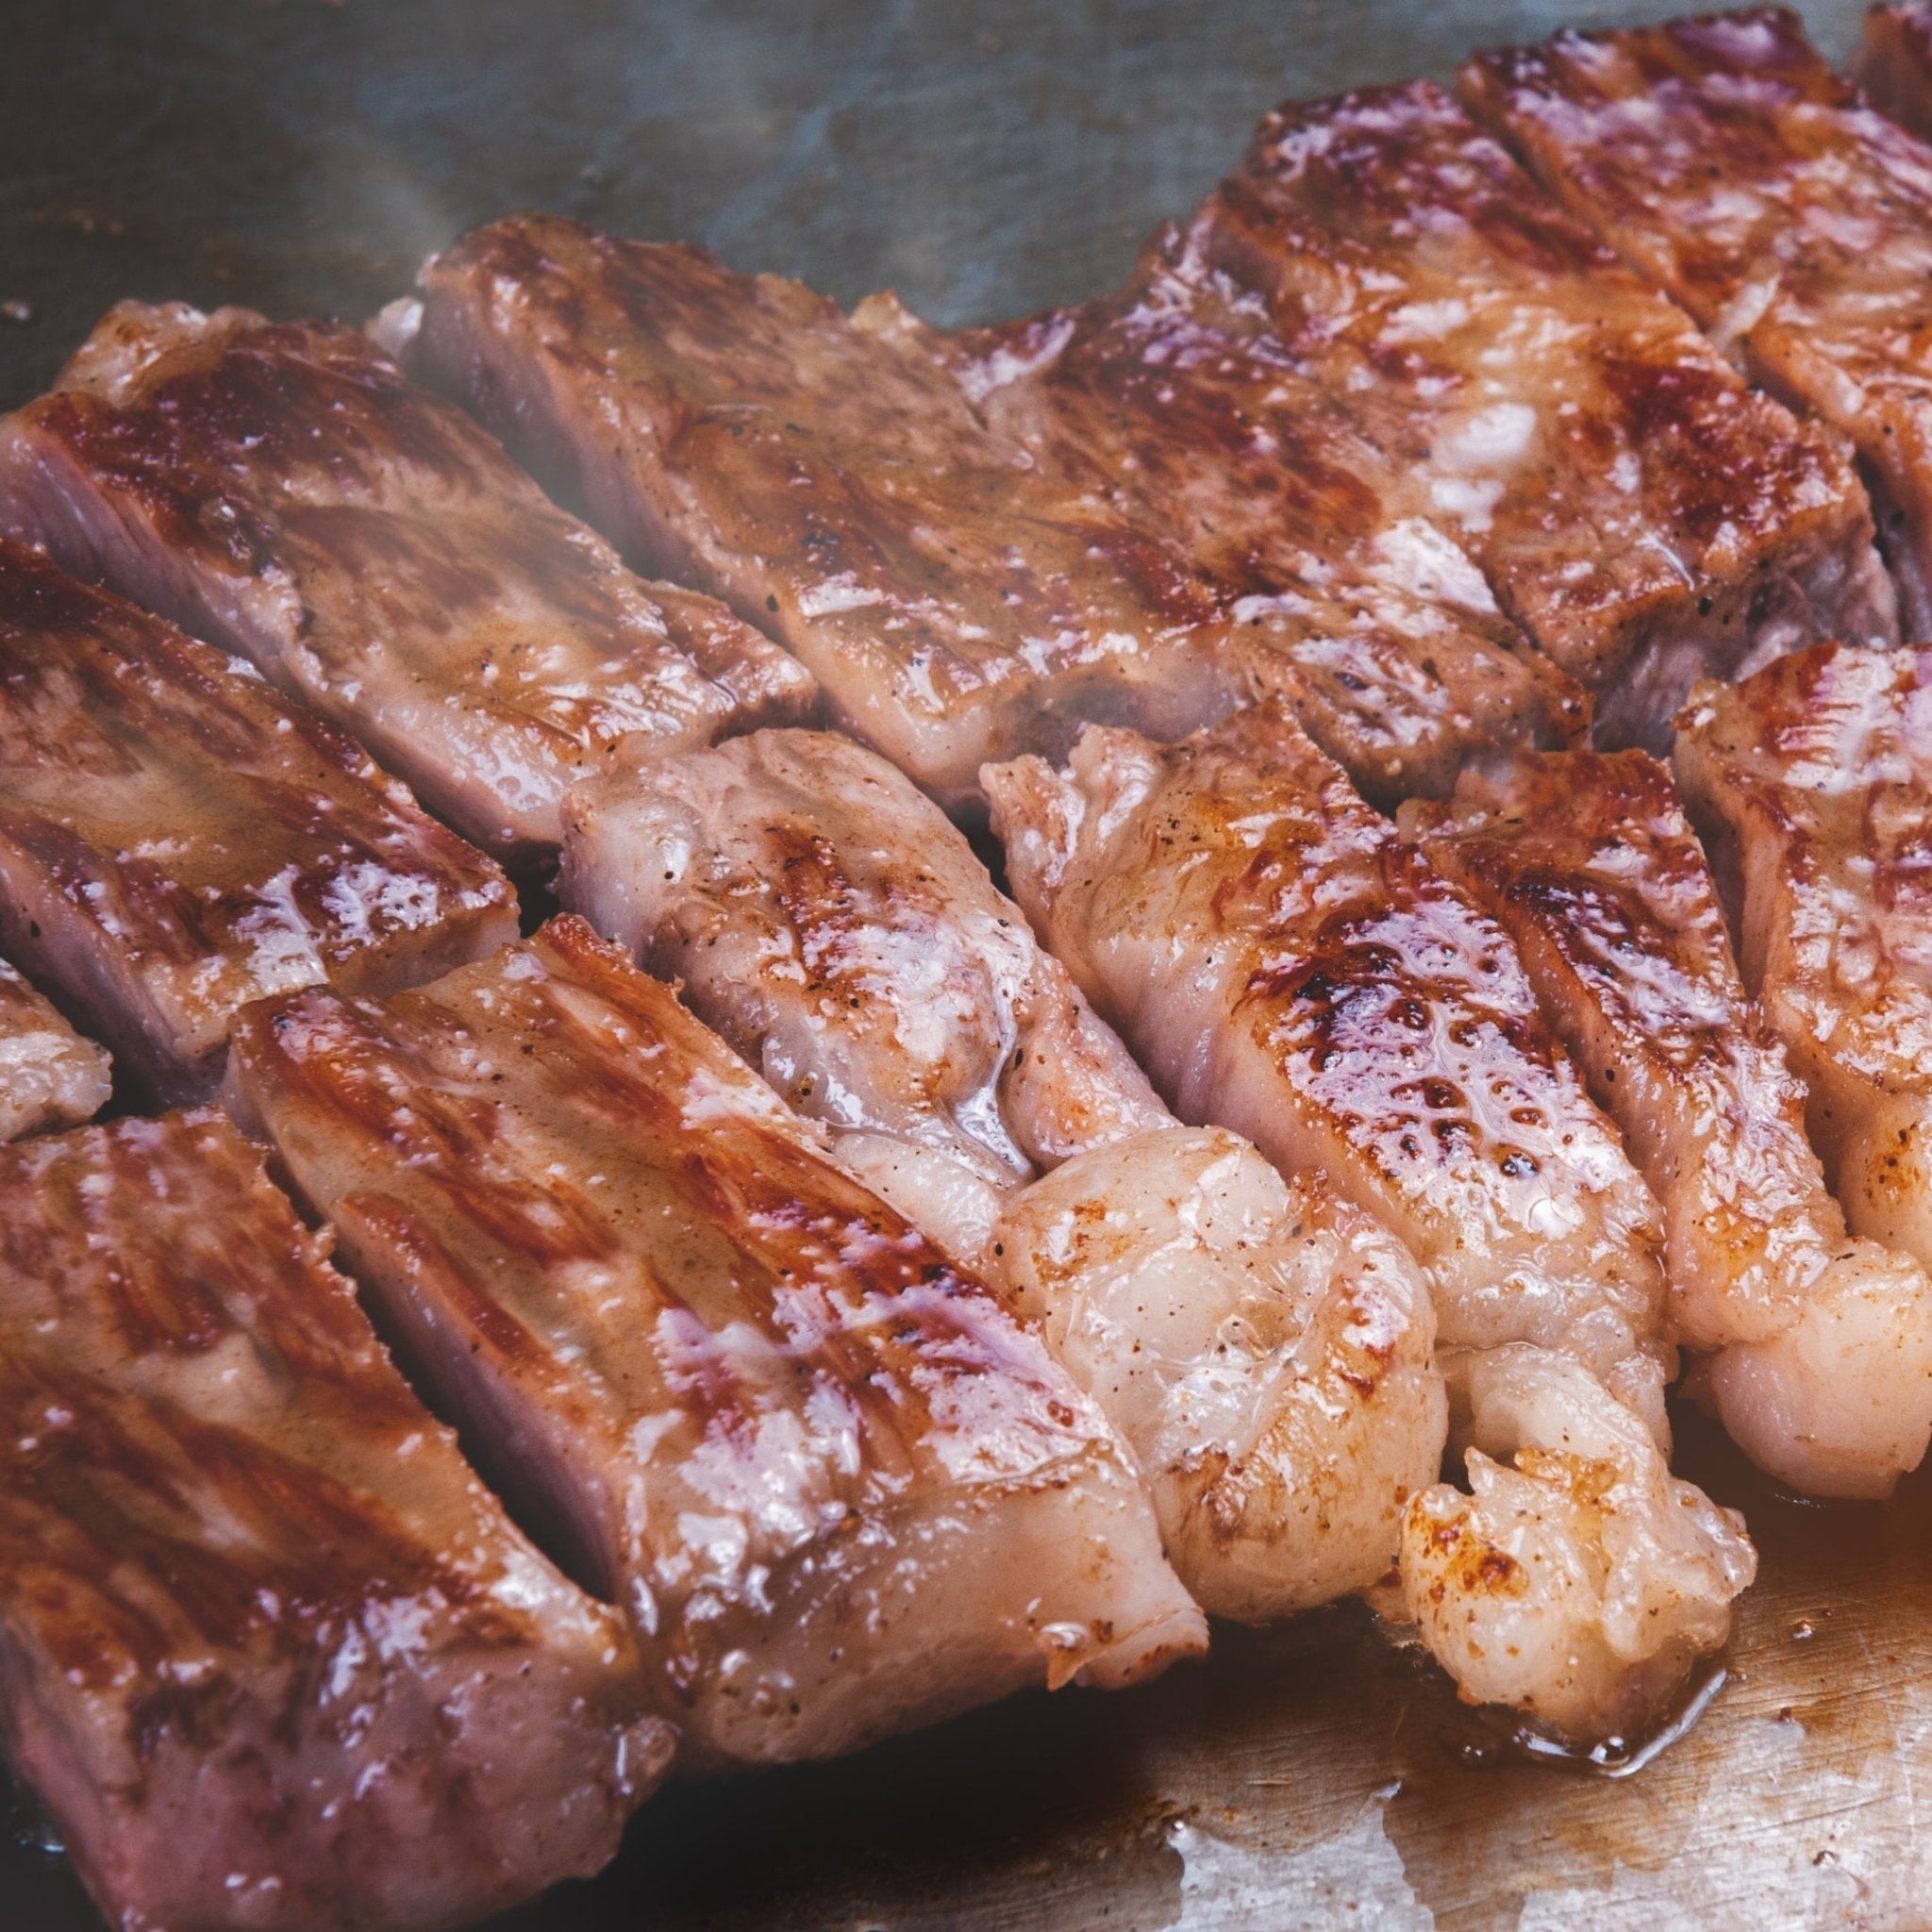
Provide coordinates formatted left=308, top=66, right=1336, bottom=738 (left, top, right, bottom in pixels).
left=931, top=236, right=1588, bottom=804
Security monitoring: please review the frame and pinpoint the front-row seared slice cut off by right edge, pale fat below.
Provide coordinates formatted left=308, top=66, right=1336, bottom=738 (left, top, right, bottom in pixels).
left=1677, top=645, right=1932, bottom=1267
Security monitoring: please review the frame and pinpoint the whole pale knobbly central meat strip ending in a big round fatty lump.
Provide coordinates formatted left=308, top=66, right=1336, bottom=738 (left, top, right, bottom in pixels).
left=560, top=730, right=1443, bottom=1619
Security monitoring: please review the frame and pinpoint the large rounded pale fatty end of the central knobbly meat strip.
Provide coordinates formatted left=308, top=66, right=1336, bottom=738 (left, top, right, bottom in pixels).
left=995, top=1126, right=1449, bottom=1623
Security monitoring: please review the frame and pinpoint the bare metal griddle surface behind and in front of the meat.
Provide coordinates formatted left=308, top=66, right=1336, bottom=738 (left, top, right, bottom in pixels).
left=0, top=0, right=1932, bottom=1932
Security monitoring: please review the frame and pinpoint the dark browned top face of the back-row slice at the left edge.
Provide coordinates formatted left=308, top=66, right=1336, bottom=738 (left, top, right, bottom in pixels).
left=0, top=542, right=508, bottom=1004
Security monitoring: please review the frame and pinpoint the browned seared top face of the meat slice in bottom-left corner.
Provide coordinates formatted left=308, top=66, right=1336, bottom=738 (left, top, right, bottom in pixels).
left=0, top=1111, right=527, bottom=1685
